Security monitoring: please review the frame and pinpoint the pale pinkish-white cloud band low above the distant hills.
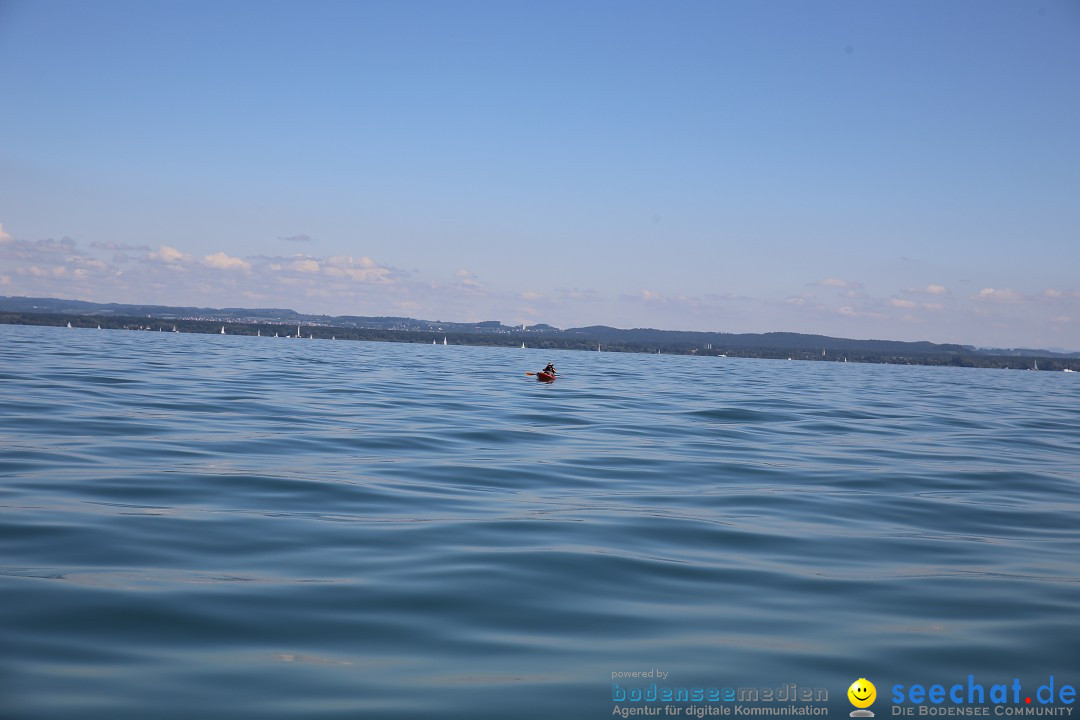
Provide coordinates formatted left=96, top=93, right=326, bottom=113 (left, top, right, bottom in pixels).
left=0, top=225, right=1080, bottom=348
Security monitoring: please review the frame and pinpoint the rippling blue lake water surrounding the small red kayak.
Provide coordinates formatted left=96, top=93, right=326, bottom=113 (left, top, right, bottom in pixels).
left=0, top=326, right=1080, bottom=719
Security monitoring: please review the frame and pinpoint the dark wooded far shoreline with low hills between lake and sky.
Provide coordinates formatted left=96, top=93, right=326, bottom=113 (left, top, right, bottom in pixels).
left=0, top=312, right=1080, bottom=371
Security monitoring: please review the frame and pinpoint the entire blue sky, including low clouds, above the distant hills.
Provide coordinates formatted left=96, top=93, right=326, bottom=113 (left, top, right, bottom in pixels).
left=0, top=0, right=1080, bottom=350
